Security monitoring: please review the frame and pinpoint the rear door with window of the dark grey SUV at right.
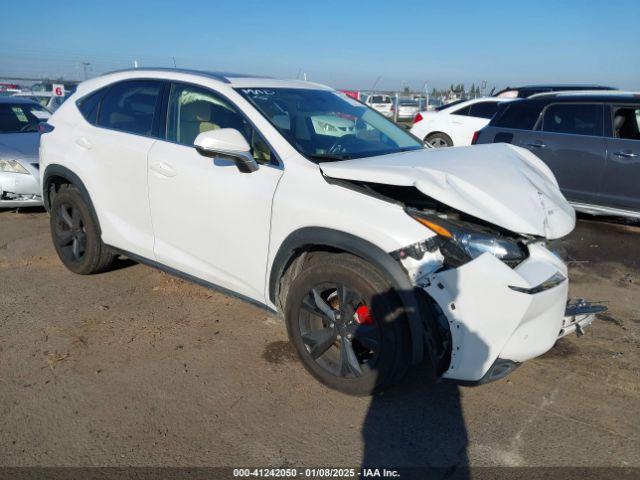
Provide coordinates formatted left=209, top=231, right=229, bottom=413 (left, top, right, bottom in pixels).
left=513, top=103, right=606, bottom=204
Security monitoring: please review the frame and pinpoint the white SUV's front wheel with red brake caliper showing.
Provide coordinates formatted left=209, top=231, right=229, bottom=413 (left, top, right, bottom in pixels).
left=285, top=254, right=410, bottom=395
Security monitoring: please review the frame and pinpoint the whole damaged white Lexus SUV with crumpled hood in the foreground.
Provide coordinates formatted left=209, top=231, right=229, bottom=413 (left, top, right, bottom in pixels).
left=40, top=69, right=598, bottom=394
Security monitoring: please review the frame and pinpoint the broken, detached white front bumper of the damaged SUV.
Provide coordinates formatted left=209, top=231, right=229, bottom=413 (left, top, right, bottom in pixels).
left=418, top=245, right=604, bottom=383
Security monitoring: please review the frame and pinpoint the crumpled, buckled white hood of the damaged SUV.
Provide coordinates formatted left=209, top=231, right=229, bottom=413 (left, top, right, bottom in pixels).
left=320, top=143, right=576, bottom=239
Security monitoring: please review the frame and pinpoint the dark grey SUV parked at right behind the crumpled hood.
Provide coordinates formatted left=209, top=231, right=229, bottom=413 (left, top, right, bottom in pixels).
left=476, top=91, right=640, bottom=218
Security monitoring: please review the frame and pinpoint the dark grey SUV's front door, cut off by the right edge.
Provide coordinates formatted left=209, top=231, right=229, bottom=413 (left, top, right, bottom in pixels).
left=602, top=105, right=640, bottom=211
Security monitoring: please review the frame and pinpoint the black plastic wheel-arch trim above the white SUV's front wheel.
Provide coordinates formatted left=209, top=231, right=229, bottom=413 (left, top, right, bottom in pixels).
left=268, top=227, right=437, bottom=375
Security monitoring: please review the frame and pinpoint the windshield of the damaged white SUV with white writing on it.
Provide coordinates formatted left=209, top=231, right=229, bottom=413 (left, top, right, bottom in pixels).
left=237, top=88, right=424, bottom=161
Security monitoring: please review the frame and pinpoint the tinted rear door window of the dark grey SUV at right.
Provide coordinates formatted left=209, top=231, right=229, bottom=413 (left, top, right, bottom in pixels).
left=542, top=104, right=602, bottom=136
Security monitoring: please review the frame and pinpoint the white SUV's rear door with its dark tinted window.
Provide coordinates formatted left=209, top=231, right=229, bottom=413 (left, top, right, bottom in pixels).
left=72, top=80, right=165, bottom=259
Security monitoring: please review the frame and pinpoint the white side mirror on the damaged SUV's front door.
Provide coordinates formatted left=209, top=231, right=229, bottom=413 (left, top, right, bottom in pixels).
left=193, top=128, right=258, bottom=173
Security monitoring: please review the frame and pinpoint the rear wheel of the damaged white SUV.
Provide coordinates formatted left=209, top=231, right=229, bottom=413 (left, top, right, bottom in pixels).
left=49, top=186, right=116, bottom=275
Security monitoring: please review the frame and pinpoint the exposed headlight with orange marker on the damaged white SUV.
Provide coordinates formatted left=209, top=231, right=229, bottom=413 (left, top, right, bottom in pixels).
left=408, top=211, right=527, bottom=267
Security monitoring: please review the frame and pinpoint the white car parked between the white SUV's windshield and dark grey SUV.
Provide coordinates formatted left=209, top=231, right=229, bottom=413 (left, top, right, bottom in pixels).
left=411, top=97, right=504, bottom=148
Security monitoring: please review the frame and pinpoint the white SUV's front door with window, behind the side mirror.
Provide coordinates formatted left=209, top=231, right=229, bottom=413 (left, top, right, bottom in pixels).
left=148, top=84, right=282, bottom=302
